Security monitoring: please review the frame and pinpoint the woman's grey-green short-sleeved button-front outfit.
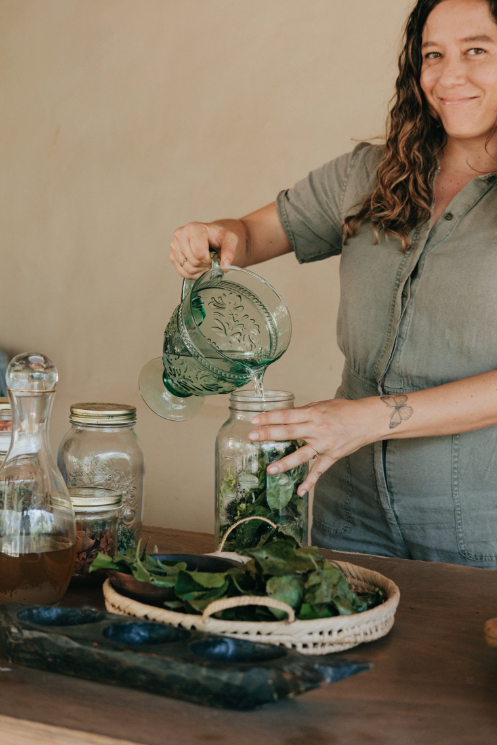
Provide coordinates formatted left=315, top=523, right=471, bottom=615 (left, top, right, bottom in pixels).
left=277, top=143, right=497, bottom=568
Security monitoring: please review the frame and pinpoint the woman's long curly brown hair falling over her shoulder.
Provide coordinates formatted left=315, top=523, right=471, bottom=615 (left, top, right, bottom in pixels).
left=343, top=0, right=497, bottom=251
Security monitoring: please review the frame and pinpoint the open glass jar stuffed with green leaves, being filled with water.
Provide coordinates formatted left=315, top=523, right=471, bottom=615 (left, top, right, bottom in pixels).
left=216, top=390, right=308, bottom=551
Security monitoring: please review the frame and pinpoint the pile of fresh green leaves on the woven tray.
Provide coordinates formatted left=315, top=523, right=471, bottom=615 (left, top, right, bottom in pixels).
left=90, top=539, right=384, bottom=621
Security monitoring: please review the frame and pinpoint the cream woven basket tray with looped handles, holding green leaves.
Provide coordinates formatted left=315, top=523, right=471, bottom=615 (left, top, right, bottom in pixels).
left=103, top=561, right=400, bottom=654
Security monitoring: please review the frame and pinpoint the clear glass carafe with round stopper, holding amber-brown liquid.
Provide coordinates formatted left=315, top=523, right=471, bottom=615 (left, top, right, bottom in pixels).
left=0, top=354, right=76, bottom=604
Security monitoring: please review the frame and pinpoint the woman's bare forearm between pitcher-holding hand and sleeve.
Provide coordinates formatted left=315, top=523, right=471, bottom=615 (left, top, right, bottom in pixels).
left=208, top=202, right=292, bottom=267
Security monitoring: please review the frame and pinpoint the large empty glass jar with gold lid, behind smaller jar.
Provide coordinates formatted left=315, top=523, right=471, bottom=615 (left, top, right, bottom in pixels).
left=58, top=403, right=144, bottom=553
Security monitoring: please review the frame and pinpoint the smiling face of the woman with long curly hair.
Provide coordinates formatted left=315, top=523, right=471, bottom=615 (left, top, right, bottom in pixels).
left=421, top=0, right=497, bottom=141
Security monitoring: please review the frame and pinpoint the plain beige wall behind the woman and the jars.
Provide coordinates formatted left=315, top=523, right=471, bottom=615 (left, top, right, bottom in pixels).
left=0, top=0, right=412, bottom=531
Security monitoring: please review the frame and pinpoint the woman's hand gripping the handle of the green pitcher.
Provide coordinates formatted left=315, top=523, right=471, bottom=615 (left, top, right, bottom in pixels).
left=169, top=220, right=241, bottom=279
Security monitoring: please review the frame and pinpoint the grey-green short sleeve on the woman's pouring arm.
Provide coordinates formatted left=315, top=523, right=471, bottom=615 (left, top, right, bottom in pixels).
left=276, top=148, right=357, bottom=264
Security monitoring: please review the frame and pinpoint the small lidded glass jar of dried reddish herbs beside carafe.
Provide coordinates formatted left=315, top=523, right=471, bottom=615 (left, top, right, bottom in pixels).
left=69, top=486, right=122, bottom=585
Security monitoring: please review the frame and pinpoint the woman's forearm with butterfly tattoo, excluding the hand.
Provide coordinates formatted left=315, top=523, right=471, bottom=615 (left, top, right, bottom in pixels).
left=364, top=371, right=497, bottom=442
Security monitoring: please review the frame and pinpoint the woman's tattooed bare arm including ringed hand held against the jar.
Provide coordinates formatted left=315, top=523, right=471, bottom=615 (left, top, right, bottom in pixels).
left=249, top=371, right=497, bottom=495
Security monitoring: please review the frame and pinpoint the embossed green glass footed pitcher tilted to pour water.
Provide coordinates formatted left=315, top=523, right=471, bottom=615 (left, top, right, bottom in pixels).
left=138, top=251, right=292, bottom=421
